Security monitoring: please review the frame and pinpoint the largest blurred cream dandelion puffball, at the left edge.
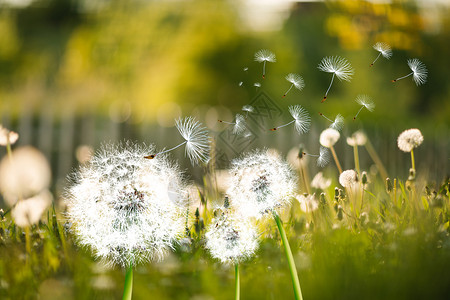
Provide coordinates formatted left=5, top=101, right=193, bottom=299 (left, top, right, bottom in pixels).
left=0, top=146, right=51, bottom=206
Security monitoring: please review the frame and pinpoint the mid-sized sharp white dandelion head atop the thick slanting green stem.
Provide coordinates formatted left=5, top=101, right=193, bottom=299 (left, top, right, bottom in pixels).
left=227, top=150, right=296, bottom=219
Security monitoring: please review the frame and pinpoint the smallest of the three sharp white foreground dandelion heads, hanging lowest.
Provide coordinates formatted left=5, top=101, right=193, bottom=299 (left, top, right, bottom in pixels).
left=205, top=214, right=259, bottom=264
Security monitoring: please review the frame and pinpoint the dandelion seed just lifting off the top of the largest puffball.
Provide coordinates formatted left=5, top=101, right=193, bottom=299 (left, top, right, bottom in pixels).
left=144, top=117, right=210, bottom=165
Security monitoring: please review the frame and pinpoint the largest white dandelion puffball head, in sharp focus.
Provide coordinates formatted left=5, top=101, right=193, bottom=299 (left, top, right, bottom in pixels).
left=65, top=142, right=187, bottom=268
